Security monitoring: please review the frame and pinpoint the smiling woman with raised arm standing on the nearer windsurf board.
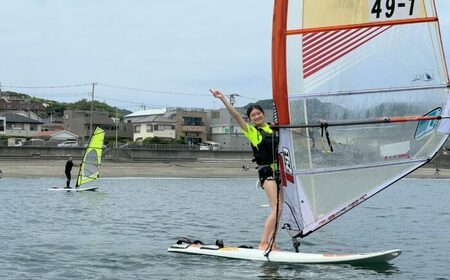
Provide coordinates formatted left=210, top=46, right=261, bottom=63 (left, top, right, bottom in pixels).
left=209, top=89, right=283, bottom=251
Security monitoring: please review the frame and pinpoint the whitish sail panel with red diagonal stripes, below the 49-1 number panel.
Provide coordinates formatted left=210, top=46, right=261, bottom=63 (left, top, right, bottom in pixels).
left=287, top=23, right=448, bottom=95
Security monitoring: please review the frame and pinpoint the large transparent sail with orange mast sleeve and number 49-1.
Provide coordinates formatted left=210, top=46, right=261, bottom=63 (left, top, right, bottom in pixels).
left=272, top=0, right=450, bottom=237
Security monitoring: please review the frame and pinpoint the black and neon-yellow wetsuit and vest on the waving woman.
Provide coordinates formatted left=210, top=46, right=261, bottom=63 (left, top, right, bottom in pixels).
left=242, top=123, right=278, bottom=186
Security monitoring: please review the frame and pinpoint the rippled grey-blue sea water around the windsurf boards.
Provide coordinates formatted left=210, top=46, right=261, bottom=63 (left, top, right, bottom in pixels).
left=0, top=178, right=450, bottom=279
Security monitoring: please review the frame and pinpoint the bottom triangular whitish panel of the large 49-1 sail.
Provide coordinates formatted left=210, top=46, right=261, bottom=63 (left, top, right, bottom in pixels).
left=286, top=162, right=423, bottom=235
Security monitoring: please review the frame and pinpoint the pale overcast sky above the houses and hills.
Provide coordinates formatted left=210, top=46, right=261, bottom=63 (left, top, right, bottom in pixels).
left=0, top=0, right=450, bottom=111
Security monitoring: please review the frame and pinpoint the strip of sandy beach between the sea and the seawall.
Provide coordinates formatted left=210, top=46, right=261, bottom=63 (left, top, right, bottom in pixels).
left=0, top=159, right=450, bottom=179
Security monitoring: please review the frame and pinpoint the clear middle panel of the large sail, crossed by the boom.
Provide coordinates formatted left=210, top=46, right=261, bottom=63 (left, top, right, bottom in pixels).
left=289, top=89, right=448, bottom=170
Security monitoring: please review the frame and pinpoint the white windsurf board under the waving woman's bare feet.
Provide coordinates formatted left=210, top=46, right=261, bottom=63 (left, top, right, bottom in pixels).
left=168, top=242, right=401, bottom=264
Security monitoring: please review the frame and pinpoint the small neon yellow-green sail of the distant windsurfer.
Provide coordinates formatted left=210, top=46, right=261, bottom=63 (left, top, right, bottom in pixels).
left=76, top=127, right=105, bottom=187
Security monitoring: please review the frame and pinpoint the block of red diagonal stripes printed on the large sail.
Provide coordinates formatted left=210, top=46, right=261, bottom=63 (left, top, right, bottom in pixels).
left=303, top=26, right=392, bottom=78
